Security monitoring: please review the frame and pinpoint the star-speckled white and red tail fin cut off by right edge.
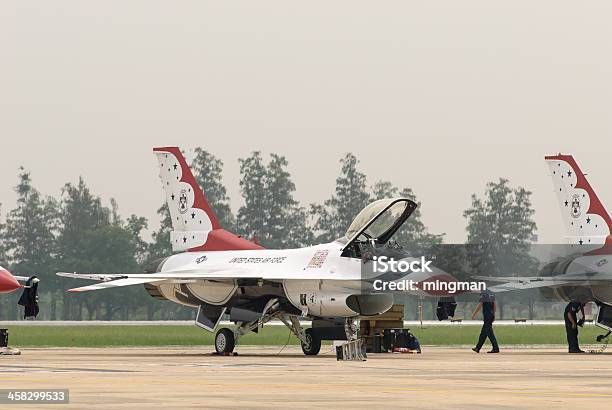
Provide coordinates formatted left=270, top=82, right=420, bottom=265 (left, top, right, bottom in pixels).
left=545, top=154, right=612, bottom=245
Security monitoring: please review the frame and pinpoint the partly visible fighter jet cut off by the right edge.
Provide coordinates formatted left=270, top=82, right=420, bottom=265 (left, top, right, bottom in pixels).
left=475, top=154, right=612, bottom=331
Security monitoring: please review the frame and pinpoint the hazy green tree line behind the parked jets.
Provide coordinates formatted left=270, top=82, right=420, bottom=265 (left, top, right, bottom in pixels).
left=0, top=148, right=536, bottom=320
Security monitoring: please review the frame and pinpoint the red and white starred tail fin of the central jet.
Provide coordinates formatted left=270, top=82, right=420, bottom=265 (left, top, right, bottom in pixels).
left=153, top=147, right=261, bottom=251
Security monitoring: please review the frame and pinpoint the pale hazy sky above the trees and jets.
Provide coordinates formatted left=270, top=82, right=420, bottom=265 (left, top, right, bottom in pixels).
left=0, top=0, right=612, bottom=242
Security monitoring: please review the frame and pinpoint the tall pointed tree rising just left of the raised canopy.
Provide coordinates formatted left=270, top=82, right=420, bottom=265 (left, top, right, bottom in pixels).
left=310, top=153, right=370, bottom=242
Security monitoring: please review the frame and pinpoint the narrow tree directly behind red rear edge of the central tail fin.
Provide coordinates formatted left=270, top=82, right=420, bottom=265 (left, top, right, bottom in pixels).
left=191, top=148, right=236, bottom=231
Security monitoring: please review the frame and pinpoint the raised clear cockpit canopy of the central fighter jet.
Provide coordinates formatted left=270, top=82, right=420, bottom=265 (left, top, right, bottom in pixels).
left=340, top=198, right=417, bottom=258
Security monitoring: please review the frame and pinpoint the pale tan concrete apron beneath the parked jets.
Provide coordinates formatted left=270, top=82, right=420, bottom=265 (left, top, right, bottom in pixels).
left=0, top=346, right=612, bottom=409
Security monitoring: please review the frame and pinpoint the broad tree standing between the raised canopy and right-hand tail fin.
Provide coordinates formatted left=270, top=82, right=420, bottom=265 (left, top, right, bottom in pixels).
left=463, top=178, right=538, bottom=318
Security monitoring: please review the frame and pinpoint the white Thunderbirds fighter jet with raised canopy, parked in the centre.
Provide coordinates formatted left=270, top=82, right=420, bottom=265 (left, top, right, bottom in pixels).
left=57, top=147, right=453, bottom=355
